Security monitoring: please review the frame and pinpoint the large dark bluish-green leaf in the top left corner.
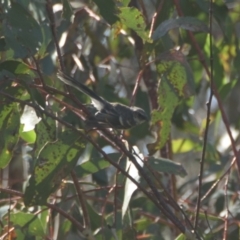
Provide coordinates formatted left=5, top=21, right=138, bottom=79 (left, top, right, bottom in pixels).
left=3, top=2, right=43, bottom=58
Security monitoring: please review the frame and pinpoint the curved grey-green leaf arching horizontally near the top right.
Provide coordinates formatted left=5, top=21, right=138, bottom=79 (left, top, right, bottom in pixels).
left=152, top=17, right=208, bottom=40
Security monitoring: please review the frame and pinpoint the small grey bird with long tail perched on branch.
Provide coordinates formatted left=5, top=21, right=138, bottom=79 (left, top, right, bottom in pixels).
left=58, top=72, right=148, bottom=129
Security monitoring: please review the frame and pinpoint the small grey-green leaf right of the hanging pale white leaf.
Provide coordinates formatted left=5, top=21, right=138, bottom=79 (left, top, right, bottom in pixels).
left=148, top=157, right=187, bottom=177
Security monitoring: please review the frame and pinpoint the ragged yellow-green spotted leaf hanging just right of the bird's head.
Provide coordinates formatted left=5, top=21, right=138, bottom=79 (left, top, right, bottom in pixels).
left=147, top=51, right=194, bottom=155
